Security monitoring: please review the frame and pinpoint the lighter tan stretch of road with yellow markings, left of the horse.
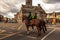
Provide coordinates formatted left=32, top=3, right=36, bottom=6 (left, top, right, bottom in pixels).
left=0, top=22, right=21, bottom=40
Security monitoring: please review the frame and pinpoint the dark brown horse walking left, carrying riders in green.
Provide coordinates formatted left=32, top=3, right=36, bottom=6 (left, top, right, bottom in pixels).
left=22, top=15, right=47, bottom=35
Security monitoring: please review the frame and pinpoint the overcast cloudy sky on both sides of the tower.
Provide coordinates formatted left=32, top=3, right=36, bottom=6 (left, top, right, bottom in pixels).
left=0, top=0, right=60, bottom=18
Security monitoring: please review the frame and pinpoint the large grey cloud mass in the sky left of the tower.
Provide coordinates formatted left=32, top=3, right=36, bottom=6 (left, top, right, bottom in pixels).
left=0, top=0, right=24, bottom=17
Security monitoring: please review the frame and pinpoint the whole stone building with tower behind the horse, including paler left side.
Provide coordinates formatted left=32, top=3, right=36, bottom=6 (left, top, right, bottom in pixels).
left=15, top=0, right=46, bottom=22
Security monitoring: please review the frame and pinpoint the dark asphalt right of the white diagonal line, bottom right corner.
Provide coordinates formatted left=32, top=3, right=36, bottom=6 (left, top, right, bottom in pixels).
left=45, top=29, right=60, bottom=40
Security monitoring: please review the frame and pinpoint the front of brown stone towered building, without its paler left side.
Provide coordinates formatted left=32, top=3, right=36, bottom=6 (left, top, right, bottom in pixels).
left=21, top=0, right=46, bottom=16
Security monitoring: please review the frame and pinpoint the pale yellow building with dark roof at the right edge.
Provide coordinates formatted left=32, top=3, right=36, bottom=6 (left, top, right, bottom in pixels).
left=47, top=12, right=60, bottom=23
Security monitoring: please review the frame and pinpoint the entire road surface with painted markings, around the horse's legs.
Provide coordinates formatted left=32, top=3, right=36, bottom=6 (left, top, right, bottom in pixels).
left=0, top=23, right=60, bottom=40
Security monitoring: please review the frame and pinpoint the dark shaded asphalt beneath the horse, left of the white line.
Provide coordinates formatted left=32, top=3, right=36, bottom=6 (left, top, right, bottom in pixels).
left=3, top=28, right=53, bottom=40
